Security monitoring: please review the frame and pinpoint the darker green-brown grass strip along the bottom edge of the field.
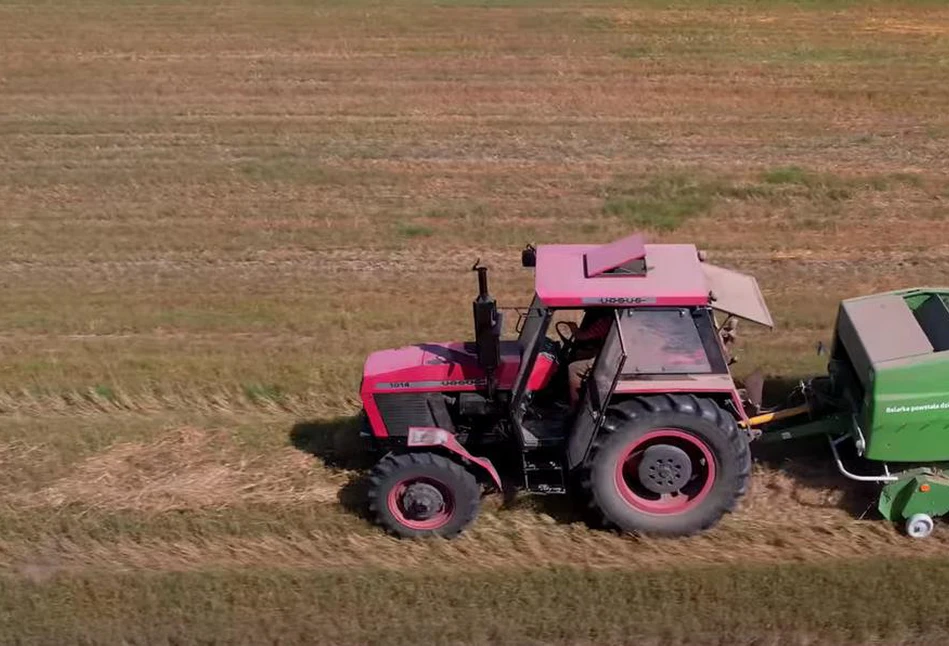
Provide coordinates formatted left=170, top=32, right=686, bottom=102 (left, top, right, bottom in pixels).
left=0, top=559, right=949, bottom=646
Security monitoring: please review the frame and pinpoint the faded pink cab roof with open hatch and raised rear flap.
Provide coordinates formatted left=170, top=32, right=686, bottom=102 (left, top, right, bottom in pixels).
left=535, top=235, right=773, bottom=327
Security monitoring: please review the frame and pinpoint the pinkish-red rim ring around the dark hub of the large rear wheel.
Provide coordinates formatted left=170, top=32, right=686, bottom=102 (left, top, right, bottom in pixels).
left=615, top=428, right=715, bottom=515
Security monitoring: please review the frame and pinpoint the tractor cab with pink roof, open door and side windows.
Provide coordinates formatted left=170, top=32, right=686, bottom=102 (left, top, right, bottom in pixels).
left=488, top=236, right=772, bottom=490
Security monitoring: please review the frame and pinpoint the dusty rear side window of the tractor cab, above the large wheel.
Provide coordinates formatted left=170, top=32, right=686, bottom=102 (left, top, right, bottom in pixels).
left=620, top=308, right=727, bottom=375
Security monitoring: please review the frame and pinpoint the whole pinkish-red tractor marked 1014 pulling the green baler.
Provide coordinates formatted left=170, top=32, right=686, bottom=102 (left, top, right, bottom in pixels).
left=360, top=235, right=772, bottom=537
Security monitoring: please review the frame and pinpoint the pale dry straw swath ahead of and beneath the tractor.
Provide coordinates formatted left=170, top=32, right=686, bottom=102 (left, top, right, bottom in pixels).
left=0, top=418, right=949, bottom=571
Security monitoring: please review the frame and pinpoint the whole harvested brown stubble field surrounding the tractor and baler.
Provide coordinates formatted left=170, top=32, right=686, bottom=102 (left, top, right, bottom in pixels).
left=0, top=0, right=949, bottom=646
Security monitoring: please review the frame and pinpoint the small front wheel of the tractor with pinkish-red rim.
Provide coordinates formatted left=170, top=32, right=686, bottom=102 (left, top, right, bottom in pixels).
left=369, top=453, right=481, bottom=538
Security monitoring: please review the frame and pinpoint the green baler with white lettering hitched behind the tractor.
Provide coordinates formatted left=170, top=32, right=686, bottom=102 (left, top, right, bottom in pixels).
left=750, top=288, right=949, bottom=538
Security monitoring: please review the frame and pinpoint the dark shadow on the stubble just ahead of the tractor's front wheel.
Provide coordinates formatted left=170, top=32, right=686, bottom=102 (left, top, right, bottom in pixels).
left=289, top=415, right=373, bottom=520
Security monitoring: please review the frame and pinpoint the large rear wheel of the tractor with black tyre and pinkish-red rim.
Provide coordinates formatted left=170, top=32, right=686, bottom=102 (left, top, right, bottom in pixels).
left=585, top=395, right=751, bottom=536
